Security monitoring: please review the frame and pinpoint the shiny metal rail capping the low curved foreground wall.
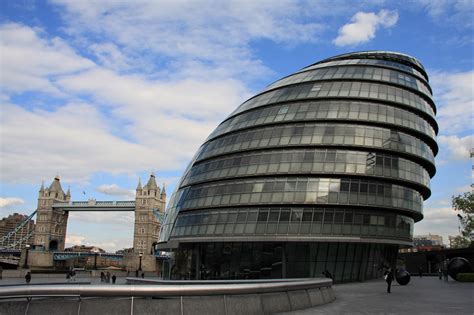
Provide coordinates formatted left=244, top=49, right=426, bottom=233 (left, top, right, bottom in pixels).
left=0, top=278, right=332, bottom=299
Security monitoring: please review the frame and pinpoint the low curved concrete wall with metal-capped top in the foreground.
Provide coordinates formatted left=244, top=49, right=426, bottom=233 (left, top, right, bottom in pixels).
left=0, top=279, right=335, bottom=315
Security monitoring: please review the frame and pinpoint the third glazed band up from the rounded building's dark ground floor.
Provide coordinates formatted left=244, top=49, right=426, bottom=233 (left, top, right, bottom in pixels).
left=183, top=149, right=430, bottom=189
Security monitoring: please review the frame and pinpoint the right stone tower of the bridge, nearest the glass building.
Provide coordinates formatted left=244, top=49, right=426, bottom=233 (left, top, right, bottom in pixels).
left=133, top=173, right=166, bottom=271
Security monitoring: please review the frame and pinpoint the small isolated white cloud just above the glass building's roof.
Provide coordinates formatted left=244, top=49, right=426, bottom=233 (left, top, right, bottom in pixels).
left=333, top=10, right=398, bottom=46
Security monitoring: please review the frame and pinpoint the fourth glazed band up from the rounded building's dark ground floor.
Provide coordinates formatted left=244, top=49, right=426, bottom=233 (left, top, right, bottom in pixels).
left=197, top=122, right=434, bottom=168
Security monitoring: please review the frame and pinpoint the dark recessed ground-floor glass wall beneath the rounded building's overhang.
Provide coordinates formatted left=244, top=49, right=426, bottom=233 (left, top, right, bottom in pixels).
left=173, top=241, right=398, bottom=283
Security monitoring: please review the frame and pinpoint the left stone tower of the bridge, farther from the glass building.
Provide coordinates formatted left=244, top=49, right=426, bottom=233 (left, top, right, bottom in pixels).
left=34, top=176, right=71, bottom=251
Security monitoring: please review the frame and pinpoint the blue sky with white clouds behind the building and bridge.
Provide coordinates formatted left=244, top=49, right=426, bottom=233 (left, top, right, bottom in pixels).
left=0, top=0, right=474, bottom=251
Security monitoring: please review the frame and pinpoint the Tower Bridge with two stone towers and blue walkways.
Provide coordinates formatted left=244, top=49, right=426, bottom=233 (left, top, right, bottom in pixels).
left=4, top=174, right=168, bottom=271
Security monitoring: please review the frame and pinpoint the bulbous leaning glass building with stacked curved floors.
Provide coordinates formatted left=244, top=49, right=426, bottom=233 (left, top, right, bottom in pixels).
left=160, top=51, right=438, bottom=282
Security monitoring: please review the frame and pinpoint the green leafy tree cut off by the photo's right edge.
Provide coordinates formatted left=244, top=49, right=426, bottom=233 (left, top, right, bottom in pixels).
left=452, top=192, right=474, bottom=247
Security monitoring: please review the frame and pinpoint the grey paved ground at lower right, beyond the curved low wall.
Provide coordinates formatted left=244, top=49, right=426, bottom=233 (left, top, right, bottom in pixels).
left=283, top=277, right=474, bottom=315
